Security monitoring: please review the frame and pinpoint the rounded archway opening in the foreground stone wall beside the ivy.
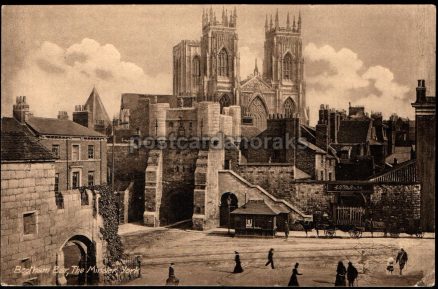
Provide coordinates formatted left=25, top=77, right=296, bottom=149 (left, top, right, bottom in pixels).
left=56, top=235, right=99, bottom=285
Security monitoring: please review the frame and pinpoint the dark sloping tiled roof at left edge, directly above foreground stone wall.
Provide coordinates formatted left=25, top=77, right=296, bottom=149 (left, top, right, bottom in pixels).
left=1, top=117, right=55, bottom=162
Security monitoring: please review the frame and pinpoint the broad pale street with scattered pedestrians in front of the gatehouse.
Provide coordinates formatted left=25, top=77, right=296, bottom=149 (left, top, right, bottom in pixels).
left=122, top=228, right=435, bottom=287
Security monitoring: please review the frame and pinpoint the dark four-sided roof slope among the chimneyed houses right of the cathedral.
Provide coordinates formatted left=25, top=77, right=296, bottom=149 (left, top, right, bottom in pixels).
left=338, top=119, right=371, bottom=143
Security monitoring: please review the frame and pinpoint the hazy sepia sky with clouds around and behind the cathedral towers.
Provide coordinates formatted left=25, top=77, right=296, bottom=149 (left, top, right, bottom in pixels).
left=1, top=5, right=436, bottom=125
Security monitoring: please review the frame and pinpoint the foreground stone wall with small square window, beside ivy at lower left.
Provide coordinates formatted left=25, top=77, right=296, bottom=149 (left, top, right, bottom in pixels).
left=1, top=163, right=105, bottom=285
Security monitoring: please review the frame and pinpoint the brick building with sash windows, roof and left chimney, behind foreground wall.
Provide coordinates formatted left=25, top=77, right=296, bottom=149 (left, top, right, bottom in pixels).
left=10, top=96, right=107, bottom=192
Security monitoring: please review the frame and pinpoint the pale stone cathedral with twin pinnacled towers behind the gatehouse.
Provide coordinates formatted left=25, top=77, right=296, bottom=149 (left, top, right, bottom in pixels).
left=173, top=8, right=309, bottom=131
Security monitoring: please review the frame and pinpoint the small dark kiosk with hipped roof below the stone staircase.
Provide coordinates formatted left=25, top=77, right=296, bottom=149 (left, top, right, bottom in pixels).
left=231, top=200, right=280, bottom=237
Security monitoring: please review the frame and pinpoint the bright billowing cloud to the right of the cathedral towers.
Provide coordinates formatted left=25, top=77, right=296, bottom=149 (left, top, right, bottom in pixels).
left=304, top=43, right=414, bottom=124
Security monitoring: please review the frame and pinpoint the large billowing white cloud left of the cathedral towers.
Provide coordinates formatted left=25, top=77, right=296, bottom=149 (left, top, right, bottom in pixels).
left=10, top=38, right=172, bottom=119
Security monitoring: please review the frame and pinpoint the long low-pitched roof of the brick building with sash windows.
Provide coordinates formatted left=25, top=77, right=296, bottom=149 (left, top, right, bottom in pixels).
left=26, top=117, right=106, bottom=138
